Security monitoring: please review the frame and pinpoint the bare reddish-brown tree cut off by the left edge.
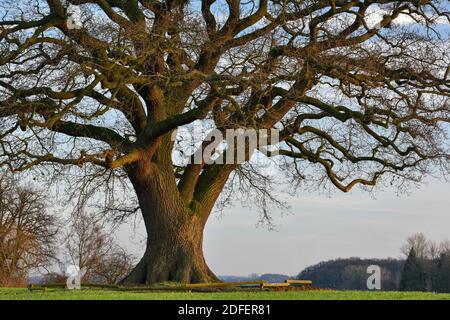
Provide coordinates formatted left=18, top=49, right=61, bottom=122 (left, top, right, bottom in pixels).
left=0, top=176, right=59, bottom=286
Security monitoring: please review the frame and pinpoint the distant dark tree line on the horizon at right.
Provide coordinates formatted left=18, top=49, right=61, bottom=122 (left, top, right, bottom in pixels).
left=297, top=233, right=450, bottom=292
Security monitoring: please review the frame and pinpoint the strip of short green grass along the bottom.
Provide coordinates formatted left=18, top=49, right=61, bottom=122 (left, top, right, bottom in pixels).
left=0, top=288, right=450, bottom=300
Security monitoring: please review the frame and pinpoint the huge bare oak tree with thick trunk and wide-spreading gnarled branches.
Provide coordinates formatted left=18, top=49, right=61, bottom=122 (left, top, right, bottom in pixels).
left=0, top=0, right=450, bottom=284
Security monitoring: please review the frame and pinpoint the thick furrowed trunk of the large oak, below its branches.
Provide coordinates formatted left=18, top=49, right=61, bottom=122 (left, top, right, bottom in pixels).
left=122, top=161, right=218, bottom=285
